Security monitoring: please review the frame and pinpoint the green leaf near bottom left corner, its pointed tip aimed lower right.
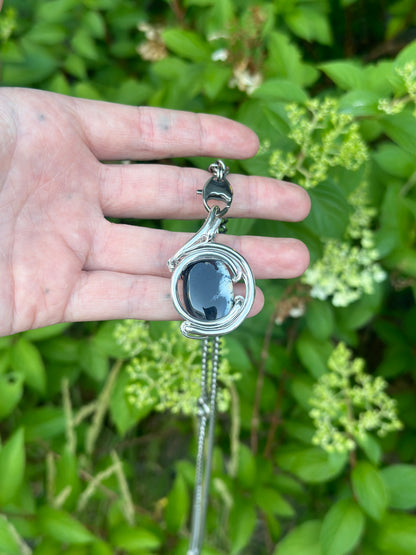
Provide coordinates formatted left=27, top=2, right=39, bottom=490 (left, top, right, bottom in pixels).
left=38, top=505, right=96, bottom=545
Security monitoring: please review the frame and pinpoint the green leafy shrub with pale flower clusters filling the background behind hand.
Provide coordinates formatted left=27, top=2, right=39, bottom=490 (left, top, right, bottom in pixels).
left=0, top=0, right=416, bottom=555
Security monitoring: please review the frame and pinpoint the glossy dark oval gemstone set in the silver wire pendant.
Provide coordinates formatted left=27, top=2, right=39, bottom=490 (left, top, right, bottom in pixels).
left=182, top=260, right=234, bottom=320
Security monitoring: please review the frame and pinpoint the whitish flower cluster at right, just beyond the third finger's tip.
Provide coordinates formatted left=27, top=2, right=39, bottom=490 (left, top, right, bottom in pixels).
left=303, top=184, right=386, bottom=306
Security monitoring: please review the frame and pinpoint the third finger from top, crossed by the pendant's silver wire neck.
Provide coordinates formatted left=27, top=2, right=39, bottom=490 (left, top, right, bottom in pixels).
left=85, top=222, right=309, bottom=279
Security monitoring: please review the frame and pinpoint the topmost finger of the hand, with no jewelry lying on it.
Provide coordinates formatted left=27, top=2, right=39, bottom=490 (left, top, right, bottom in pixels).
left=71, top=99, right=258, bottom=160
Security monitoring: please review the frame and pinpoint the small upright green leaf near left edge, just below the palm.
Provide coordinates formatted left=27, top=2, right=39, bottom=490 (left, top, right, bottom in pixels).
left=11, top=337, right=46, bottom=394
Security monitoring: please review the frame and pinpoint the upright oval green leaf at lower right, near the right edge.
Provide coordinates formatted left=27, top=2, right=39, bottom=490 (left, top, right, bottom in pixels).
left=351, top=461, right=388, bottom=520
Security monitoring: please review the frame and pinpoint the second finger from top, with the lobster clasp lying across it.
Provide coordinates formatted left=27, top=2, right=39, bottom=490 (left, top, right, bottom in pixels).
left=100, top=164, right=310, bottom=221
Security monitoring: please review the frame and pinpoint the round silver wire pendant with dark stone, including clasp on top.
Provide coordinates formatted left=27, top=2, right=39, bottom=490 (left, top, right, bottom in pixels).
left=168, top=160, right=255, bottom=338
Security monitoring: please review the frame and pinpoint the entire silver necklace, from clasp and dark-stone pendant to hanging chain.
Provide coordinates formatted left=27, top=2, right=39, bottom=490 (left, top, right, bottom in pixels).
left=168, top=160, right=255, bottom=555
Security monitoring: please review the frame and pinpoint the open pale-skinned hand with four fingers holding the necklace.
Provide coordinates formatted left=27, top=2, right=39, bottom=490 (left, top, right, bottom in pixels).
left=0, top=88, right=310, bottom=335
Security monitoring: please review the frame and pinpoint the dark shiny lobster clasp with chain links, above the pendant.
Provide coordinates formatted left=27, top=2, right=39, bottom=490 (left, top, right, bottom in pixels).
left=197, top=160, right=233, bottom=218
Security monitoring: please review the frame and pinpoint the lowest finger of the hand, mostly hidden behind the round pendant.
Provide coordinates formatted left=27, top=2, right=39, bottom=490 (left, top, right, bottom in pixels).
left=64, top=271, right=264, bottom=322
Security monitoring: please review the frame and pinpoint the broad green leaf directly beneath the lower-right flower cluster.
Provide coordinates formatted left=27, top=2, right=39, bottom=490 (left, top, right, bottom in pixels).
left=276, top=446, right=347, bottom=484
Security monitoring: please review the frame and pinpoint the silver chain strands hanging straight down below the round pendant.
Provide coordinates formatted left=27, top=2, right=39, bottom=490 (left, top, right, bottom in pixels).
left=187, top=336, right=221, bottom=555
